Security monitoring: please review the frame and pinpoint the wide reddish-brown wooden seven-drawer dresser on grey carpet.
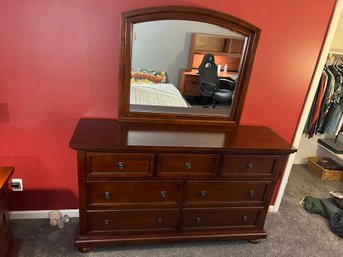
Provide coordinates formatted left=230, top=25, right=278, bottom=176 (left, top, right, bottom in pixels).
left=70, top=119, right=295, bottom=252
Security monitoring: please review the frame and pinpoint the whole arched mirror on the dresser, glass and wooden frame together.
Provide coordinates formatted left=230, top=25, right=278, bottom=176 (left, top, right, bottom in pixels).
left=119, top=7, right=260, bottom=125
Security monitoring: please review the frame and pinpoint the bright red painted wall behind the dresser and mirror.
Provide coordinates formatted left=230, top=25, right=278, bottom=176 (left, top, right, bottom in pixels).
left=0, top=0, right=335, bottom=210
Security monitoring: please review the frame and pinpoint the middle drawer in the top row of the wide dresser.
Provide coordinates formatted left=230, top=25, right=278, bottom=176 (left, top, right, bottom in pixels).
left=158, top=154, right=219, bottom=177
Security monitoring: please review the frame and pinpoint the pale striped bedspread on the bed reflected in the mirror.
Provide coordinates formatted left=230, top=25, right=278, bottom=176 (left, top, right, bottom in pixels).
left=130, top=83, right=189, bottom=107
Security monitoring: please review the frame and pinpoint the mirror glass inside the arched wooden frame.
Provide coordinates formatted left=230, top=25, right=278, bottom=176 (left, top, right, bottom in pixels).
left=127, top=20, right=248, bottom=117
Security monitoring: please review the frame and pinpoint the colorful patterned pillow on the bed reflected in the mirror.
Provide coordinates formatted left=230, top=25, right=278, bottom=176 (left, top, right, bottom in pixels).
left=131, top=68, right=167, bottom=84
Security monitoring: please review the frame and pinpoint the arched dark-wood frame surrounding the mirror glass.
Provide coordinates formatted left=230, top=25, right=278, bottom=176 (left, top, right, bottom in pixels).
left=119, top=6, right=260, bottom=126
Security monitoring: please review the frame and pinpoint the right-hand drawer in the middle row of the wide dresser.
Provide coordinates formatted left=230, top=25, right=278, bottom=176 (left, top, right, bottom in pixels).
left=184, top=181, right=270, bottom=205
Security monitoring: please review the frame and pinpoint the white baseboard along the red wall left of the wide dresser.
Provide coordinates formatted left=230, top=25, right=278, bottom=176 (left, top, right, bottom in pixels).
left=10, top=209, right=79, bottom=220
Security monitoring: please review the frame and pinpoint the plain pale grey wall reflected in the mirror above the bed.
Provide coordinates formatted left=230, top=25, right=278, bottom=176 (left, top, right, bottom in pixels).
left=132, top=20, right=239, bottom=85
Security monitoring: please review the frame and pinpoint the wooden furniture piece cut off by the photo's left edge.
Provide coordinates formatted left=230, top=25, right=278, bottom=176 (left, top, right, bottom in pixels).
left=0, top=167, right=18, bottom=257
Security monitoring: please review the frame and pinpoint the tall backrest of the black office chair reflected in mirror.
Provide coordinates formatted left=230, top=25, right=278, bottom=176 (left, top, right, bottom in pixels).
left=198, top=54, right=219, bottom=85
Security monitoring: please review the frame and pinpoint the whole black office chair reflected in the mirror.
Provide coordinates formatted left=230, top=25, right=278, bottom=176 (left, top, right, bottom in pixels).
left=199, top=54, right=236, bottom=108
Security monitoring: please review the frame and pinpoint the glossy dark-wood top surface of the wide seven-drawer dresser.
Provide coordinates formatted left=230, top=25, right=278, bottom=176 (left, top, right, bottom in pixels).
left=69, top=118, right=296, bottom=154
